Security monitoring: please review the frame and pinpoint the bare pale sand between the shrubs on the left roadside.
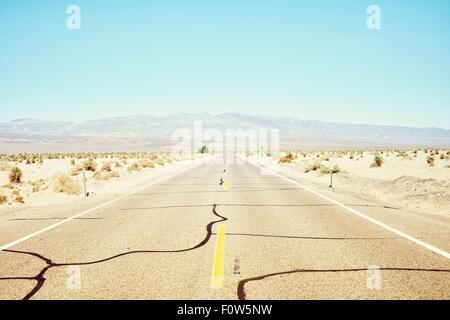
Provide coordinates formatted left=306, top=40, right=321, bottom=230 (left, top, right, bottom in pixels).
left=0, top=155, right=208, bottom=218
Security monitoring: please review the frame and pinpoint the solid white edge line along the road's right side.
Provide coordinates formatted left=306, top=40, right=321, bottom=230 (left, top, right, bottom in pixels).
left=244, top=159, right=450, bottom=259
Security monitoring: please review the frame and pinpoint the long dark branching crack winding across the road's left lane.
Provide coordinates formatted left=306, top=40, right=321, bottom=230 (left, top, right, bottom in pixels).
left=0, top=204, right=228, bottom=300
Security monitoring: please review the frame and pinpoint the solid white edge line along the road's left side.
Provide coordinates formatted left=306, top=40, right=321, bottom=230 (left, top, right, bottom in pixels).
left=0, top=160, right=204, bottom=251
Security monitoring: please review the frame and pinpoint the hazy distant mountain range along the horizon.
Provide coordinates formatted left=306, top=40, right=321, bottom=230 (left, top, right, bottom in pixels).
left=0, top=113, right=450, bottom=152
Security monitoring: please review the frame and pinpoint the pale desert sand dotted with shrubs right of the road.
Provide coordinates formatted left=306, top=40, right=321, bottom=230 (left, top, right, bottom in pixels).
left=253, top=149, right=450, bottom=217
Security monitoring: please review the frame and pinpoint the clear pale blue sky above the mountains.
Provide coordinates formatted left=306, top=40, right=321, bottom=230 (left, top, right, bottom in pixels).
left=0, top=0, right=450, bottom=128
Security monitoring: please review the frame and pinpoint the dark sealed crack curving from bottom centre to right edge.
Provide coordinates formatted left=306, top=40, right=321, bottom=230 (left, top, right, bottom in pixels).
left=236, top=267, right=450, bottom=300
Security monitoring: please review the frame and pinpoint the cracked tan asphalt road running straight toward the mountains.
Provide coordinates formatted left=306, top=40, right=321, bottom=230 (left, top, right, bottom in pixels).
left=0, top=164, right=450, bottom=299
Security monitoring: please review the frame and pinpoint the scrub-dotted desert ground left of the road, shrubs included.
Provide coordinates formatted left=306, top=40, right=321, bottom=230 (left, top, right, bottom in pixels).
left=0, top=152, right=201, bottom=214
